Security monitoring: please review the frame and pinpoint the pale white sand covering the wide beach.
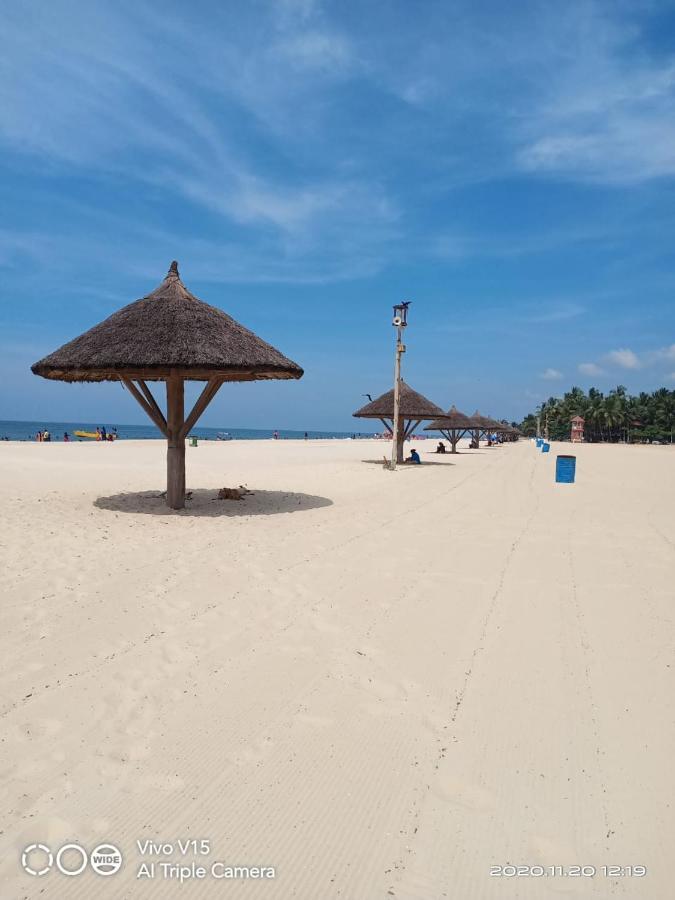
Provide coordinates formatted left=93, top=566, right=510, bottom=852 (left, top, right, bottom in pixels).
left=0, top=441, right=675, bottom=900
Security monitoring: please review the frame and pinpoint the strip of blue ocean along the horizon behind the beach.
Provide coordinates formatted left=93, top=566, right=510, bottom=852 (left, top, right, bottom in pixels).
left=0, top=419, right=373, bottom=441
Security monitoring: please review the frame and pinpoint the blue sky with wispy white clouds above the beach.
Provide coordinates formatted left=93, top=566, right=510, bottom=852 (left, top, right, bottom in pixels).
left=0, top=0, right=675, bottom=430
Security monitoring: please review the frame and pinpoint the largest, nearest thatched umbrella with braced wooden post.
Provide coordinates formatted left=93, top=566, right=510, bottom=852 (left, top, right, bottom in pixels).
left=31, top=262, right=303, bottom=509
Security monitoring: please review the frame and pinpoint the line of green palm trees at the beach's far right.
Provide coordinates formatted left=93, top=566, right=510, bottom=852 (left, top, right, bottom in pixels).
left=519, top=385, right=675, bottom=443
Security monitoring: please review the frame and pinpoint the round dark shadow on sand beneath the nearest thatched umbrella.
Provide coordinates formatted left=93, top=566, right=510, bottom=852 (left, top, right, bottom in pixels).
left=94, top=488, right=333, bottom=518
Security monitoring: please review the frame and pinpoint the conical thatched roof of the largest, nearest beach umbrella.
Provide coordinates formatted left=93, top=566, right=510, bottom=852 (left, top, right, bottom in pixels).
left=32, top=262, right=303, bottom=381
